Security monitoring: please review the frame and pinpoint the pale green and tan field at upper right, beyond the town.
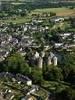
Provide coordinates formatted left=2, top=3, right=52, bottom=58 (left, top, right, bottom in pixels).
left=32, top=7, right=75, bottom=16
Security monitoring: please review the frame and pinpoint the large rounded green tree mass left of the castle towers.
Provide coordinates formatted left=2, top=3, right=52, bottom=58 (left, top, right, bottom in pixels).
left=4, top=53, right=29, bottom=75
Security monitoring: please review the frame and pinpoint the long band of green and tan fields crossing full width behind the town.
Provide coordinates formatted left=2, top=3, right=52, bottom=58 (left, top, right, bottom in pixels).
left=0, top=7, right=75, bottom=23
